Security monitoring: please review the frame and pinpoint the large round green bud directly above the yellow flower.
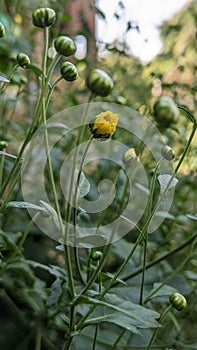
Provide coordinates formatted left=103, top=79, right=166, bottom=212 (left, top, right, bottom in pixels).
left=86, top=69, right=114, bottom=96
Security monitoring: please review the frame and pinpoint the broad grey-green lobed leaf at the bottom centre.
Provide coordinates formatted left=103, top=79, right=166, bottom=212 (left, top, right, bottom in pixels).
left=80, top=294, right=160, bottom=334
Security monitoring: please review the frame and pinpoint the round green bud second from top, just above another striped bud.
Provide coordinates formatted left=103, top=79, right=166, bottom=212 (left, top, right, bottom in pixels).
left=54, top=36, right=77, bottom=57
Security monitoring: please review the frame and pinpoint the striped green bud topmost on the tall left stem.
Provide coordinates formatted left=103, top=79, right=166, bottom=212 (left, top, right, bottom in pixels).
left=32, top=7, right=56, bottom=28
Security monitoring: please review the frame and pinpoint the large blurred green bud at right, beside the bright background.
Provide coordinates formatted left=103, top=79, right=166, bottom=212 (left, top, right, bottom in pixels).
left=153, top=96, right=179, bottom=127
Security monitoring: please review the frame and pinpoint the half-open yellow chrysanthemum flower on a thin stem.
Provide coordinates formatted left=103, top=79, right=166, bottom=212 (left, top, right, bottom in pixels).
left=89, top=111, right=118, bottom=141
